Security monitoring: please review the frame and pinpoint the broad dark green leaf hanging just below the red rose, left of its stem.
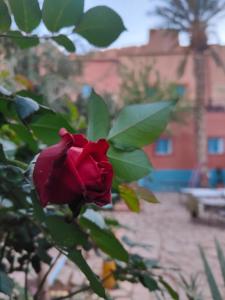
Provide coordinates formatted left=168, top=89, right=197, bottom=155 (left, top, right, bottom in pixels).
left=46, top=216, right=87, bottom=248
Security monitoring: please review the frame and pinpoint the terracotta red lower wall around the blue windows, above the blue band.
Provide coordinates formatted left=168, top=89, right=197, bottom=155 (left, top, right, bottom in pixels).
left=145, top=112, right=225, bottom=170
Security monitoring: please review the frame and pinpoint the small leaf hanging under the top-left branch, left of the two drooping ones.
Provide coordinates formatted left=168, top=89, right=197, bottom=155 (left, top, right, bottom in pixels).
left=8, top=31, right=39, bottom=49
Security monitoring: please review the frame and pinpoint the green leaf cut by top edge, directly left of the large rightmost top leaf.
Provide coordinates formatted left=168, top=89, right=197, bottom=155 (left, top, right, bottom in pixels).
left=43, top=0, right=84, bottom=32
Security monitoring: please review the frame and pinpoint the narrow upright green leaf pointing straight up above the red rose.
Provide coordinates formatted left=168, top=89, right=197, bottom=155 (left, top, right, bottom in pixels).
left=87, top=91, right=110, bottom=141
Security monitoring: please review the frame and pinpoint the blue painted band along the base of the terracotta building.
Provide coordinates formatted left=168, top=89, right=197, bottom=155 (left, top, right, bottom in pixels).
left=139, top=170, right=225, bottom=192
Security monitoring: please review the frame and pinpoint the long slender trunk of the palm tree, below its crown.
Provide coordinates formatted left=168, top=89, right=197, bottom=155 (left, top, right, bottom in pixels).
left=194, top=51, right=208, bottom=187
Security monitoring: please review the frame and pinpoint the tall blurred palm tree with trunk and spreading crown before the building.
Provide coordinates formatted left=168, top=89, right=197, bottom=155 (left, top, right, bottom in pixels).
left=153, top=0, right=225, bottom=186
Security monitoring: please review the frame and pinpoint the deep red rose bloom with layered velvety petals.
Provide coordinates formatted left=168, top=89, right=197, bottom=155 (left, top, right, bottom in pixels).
left=33, top=128, right=113, bottom=207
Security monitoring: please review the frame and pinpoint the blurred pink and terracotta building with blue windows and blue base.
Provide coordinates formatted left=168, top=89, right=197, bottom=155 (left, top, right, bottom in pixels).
left=75, top=30, right=225, bottom=190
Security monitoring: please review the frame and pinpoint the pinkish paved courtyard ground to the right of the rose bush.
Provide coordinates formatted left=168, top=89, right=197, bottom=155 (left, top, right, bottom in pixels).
left=103, top=193, right=225, bottom=300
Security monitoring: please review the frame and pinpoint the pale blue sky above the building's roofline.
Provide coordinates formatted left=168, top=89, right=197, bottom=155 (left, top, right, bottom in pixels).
left=85, top=0, right=225, bottom=48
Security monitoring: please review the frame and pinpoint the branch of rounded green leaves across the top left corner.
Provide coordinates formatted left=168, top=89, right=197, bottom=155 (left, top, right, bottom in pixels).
left=0, top=0, right=125, bottom=52
